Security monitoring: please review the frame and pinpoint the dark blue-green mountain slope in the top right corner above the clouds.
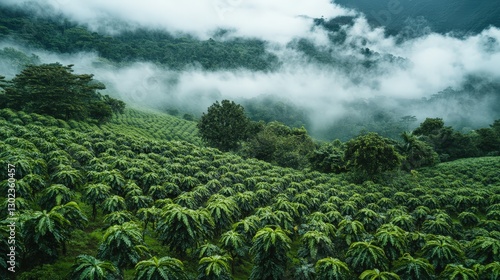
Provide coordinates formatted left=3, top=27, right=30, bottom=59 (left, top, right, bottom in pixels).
left=334, top=0, right=500, bottom=34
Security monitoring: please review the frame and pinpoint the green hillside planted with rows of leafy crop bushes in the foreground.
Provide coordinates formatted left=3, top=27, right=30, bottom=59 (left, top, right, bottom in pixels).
left=0, top=109, right=500, bottom=280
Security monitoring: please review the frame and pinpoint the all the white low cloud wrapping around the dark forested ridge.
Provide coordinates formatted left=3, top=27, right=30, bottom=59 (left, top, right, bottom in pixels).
left=0, top=0, right=500, bottom=138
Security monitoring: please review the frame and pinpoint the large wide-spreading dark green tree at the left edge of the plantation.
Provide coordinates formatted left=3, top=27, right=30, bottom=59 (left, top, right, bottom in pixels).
left=3, top=63, right=125, bottom=123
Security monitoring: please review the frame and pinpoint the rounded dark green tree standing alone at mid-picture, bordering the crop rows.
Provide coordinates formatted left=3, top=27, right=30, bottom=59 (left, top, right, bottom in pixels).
left=198, top=100, right=254, bottom=151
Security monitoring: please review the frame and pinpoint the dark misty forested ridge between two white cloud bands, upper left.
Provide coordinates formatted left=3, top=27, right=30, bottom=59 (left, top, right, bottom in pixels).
left=0, top=6, right=279, bottom=71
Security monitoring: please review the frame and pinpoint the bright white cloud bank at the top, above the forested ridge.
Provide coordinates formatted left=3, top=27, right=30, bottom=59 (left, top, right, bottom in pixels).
left=1, top=0, right=352, bottom=42
